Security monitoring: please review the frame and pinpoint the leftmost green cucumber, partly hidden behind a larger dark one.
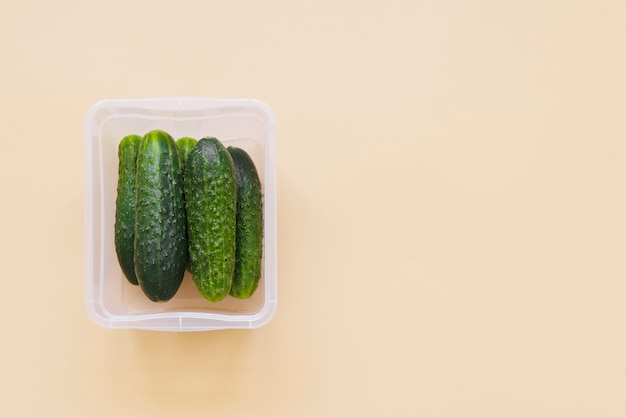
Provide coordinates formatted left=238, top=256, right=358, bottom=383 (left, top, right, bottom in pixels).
left=115, top=135, right=142, bottom=285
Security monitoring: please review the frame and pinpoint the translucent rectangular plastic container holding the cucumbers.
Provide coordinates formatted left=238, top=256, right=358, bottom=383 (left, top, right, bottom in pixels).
left=84, top=97, right=277, bottom=331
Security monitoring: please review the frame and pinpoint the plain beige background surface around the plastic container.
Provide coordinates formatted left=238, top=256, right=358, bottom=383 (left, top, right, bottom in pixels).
left=0, top=0, right=626, bottom=418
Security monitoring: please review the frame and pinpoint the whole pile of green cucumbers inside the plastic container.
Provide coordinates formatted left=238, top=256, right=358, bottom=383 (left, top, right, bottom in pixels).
left=115, top=130, right=263, bottom=302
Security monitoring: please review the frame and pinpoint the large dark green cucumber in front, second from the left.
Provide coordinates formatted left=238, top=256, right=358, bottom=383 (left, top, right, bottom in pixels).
left=135, top=130, right=187, bottom=302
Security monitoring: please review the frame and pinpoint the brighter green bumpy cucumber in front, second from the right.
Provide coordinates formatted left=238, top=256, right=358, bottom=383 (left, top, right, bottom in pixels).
left=185, top=137, right=237, bottom=302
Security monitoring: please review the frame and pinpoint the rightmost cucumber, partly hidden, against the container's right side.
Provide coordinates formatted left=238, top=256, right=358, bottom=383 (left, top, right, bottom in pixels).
left=227, top=147, right=263, bottom=299
